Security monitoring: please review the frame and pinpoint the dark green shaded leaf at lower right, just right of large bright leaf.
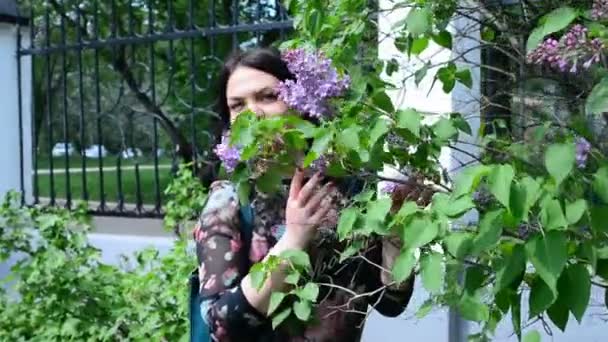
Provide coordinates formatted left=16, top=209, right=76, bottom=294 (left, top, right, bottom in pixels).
left=560, top=264, right=591, bottom=323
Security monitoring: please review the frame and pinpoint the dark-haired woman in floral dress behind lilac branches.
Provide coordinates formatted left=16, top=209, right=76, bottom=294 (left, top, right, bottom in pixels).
left=194, top=49, right=422, bottom=342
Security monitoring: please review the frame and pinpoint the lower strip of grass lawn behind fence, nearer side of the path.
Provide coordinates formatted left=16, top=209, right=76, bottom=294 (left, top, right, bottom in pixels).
left=38, top=165, right=171, bottom=204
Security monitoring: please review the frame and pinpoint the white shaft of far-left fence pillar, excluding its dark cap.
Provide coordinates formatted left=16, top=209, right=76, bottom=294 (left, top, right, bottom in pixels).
left=0, top=23, right=32, bottom=200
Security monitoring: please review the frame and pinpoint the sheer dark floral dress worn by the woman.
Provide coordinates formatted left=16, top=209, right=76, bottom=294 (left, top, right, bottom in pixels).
left=193, top=181, right=412, bottom=342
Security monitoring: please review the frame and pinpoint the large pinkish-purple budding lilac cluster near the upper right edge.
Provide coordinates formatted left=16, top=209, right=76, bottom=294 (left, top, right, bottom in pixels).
left=528, top=24, right=604, bottom=73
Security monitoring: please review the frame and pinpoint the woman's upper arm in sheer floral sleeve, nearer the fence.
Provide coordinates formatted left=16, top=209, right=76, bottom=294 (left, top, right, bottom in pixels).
left=194, top=182, right=265, bottom=341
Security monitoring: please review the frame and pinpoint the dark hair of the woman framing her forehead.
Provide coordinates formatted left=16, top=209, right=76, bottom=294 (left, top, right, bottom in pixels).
left=216, top=48, right=294, bottom=128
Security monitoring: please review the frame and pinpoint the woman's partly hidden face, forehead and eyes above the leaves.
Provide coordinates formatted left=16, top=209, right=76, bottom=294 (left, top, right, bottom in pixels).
left=226, top=66, right=288, bottom=121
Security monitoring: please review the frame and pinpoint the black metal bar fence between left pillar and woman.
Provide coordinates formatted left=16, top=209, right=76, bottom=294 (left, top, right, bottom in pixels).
left=17, top=0, right=292, bottom=217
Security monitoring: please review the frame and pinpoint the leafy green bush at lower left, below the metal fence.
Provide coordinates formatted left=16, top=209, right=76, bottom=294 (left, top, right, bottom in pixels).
left=0, top=194, right=196, bottom=341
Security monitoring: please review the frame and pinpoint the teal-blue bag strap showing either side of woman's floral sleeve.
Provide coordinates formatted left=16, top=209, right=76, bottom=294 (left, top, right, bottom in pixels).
left=189, top=205, right=253, bottom=342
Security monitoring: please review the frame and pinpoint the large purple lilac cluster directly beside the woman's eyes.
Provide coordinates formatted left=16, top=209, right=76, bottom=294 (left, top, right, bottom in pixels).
left=278, top=49, right=350, bottom=118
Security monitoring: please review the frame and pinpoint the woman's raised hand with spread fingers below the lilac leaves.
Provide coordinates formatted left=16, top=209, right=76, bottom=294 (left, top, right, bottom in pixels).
left=285, top=170, right=334, bottom=249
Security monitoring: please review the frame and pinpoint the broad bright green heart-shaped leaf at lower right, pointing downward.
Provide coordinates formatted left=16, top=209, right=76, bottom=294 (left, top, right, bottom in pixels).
left=526, top=230, right=568, bottom=294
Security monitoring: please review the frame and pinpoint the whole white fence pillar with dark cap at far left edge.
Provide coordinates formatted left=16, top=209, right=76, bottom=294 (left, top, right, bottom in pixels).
left=0, top=0, right=32, bottom=202
